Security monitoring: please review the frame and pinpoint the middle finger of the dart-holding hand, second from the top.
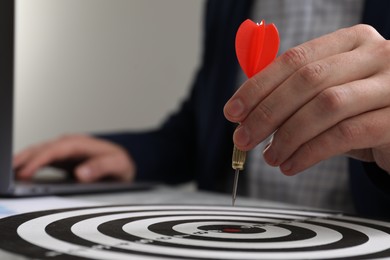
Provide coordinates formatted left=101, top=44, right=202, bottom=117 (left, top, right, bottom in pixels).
left=233, top=44, right=379, bottom=150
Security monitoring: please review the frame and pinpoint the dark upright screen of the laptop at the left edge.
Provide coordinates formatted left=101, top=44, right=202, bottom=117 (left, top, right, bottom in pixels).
left=0, top=0, right=15, bottom=192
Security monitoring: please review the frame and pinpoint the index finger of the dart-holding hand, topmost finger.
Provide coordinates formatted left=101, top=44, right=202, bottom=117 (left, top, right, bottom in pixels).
left=224, top=25, right=383, bottom=122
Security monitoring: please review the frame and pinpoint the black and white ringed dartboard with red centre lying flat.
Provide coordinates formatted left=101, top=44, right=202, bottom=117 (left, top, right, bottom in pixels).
left=0, top=205, right=390, bottom=260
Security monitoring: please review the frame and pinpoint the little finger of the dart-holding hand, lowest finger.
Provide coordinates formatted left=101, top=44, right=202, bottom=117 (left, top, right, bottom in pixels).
left=280, top=107, right=390, bottom=175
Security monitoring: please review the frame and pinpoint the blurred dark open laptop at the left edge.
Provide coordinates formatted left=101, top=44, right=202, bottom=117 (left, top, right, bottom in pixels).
left=0, top=0, right=155, bottom=196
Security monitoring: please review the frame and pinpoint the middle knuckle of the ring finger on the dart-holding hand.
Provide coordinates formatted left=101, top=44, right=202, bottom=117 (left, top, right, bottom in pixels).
left=315, top=87, right=347, bottom=113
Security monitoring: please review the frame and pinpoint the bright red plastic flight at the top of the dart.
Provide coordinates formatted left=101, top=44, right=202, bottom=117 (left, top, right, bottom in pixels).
left=236, top=19, right=279, bottom=78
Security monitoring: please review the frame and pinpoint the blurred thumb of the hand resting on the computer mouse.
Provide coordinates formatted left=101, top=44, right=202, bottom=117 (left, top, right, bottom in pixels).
left=75, top=154, right=135, bottom=182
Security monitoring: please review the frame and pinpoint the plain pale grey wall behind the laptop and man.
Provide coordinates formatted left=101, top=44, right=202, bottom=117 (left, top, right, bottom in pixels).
left=14, top=0, right=203, bottom=150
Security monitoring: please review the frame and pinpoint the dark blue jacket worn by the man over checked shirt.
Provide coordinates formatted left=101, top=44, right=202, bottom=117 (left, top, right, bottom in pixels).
left=104, top=0, right=390, bottom=218
